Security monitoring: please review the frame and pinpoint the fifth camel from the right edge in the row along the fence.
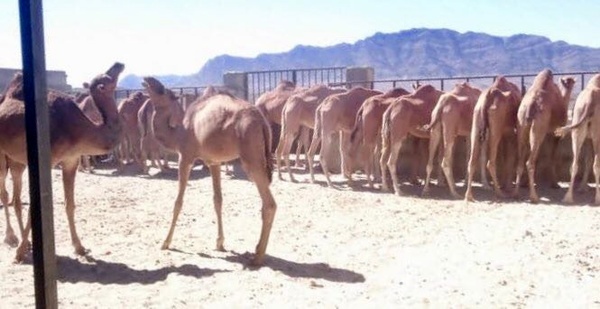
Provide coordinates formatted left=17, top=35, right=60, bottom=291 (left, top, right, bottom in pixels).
left=379, top=85, right=443, bottom=195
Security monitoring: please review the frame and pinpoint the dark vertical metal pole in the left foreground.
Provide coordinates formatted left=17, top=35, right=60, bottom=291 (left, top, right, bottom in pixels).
left=19, top=0, right=57, bottom=308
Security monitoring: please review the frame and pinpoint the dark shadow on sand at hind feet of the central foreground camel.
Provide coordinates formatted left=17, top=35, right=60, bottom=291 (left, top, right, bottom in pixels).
left=222, top=251, right=365, bottom=283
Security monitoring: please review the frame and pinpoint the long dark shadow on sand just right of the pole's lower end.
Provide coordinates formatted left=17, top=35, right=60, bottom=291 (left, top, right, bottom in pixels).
left=51, top=256, right=231, bottom=284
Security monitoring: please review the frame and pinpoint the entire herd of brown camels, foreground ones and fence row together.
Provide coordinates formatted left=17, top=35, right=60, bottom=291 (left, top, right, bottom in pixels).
left=0, top=63, right=600, bottom=265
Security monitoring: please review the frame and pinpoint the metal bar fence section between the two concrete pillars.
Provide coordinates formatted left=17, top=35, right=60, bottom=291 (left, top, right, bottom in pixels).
left=245, top=67, right=346, bottom=102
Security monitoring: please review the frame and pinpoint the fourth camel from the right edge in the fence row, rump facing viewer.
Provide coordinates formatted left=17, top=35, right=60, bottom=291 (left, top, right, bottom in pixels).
left=423, top=83, right=481, bottom=198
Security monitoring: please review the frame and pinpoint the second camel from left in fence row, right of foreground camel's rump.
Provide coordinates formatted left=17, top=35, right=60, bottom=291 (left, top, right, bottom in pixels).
left=275, top=85, right=346, bottom=182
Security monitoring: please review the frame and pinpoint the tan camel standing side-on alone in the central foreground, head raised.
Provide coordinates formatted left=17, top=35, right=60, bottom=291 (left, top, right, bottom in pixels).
left=143, top=77, right=277, bottom=266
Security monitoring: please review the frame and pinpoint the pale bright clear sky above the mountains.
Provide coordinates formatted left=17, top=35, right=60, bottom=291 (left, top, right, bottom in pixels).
left=0, top=0, right=600, bottom=86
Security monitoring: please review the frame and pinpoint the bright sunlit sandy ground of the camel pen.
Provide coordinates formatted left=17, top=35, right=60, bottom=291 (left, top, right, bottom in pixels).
left=0, top=160, right=600, bottom=308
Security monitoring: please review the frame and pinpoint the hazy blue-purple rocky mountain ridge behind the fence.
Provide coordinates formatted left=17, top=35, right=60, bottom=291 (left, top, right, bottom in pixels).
left=119, top=29, right=600, bottom=88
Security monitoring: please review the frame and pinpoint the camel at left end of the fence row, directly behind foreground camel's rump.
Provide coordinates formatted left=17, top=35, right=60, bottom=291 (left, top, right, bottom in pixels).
left=255, top=80, right=310, bottom=167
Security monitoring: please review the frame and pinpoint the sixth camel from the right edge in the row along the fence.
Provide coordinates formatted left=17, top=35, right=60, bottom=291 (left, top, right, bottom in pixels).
left=349, top=88, right=410, bottom=188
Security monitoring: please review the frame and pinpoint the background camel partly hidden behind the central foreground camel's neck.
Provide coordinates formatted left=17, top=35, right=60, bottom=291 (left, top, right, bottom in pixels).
left=137, top=99, right=169, bottom=174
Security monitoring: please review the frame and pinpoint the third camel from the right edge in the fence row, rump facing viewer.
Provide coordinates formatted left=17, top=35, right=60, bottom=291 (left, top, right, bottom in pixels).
left=465, top=76, right=521, bottom=201
